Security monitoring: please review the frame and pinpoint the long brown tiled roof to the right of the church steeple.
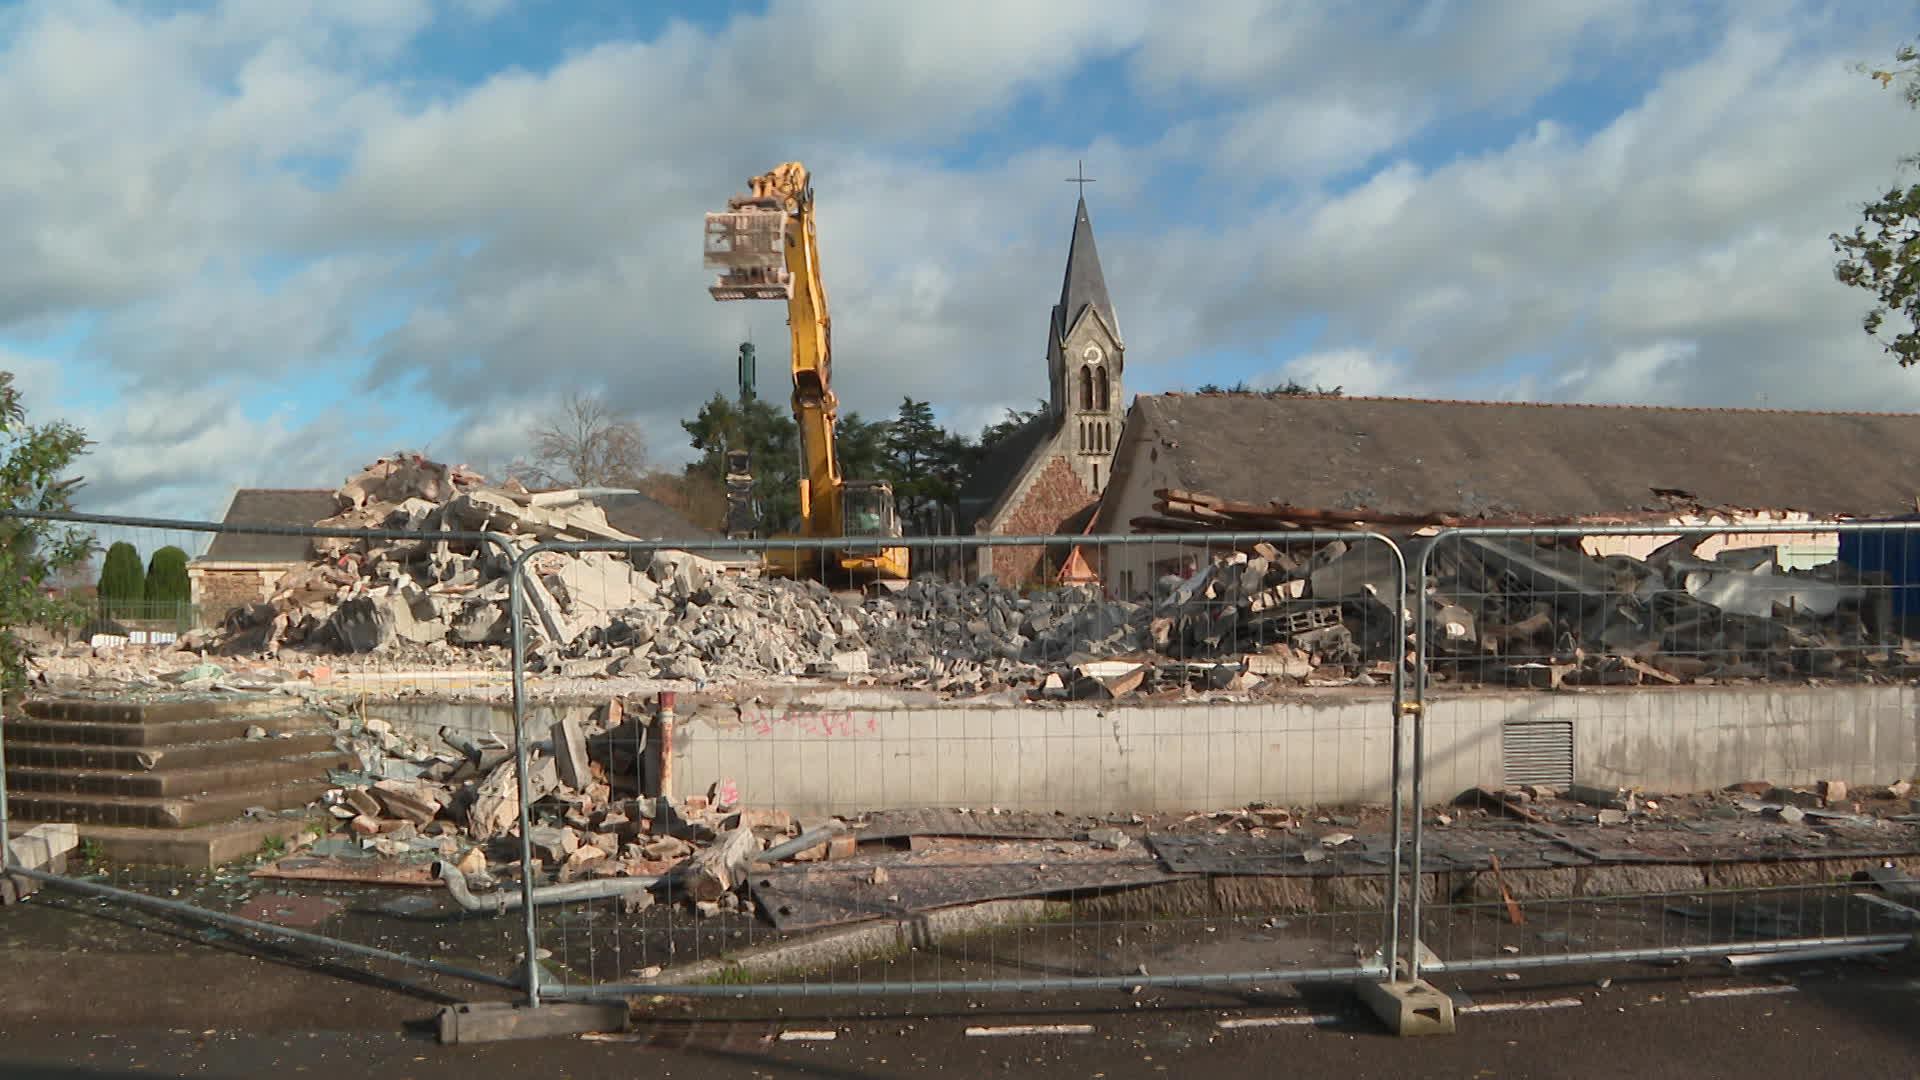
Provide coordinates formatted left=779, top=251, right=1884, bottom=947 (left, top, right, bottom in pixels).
left=1129, top=394, right=1920, bottom=517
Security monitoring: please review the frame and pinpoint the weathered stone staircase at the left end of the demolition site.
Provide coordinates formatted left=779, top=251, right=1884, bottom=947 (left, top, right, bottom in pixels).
left=4, top=694, right=351, bottom=867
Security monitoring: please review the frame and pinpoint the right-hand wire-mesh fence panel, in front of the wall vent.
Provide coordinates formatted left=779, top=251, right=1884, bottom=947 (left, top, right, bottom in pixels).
left=1409, top=523, right=1920, bottom=974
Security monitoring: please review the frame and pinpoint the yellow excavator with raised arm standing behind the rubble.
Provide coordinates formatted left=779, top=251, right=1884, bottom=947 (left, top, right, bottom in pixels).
left=707, top=161, right=908, bottom=586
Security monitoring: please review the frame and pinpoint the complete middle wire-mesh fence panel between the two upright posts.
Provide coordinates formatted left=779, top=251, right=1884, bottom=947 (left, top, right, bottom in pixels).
left=515, top=532, right=1407, bottom=999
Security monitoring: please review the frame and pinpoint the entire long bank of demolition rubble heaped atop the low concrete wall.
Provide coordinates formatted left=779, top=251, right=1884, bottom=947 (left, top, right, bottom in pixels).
left=190, top=449, right=1920, bottom=700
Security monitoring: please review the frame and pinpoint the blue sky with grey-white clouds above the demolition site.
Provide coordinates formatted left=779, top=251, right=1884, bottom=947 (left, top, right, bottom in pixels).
left=0, top=0, right=1920, bottom=519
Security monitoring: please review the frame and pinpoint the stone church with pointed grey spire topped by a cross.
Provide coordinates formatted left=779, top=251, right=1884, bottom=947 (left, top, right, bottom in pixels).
left=960, top=196, right=1127, bottom=586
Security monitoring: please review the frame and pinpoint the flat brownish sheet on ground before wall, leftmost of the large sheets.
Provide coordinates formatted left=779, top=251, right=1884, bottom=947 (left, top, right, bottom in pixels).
left=749, top=842, right=1185, bottom=930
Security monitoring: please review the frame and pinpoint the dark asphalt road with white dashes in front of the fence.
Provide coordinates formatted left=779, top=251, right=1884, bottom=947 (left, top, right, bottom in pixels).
left=0, top=909, right=1920, bottom=1080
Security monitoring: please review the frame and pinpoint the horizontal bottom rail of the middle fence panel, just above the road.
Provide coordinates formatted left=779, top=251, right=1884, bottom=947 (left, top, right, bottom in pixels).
left=547, top=967, right=1386, bottom=1001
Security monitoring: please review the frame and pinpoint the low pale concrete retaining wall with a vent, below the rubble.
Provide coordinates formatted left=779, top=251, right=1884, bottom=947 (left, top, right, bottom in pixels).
left=367, top=686, right=1920, bottom=815
